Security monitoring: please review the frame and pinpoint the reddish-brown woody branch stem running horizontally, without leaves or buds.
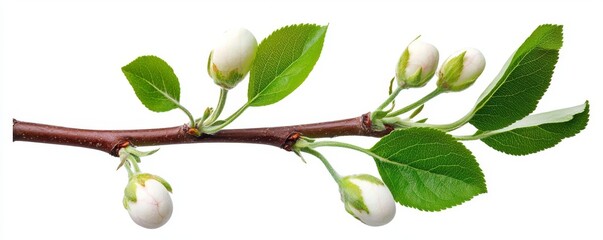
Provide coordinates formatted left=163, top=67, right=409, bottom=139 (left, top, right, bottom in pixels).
left=13, top=113, right=392, bottom=156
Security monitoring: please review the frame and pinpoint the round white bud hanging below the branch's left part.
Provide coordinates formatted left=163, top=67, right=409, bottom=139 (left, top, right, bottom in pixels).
left=123, top=173, right=173, bottom=229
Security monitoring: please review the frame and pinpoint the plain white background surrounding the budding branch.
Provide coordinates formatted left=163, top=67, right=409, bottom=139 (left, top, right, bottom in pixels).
left=0, top=1, right=603, bottom=239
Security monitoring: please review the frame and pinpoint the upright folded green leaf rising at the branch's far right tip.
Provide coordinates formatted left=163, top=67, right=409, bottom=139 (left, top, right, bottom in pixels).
left=470, top=25, right=563, bottom=131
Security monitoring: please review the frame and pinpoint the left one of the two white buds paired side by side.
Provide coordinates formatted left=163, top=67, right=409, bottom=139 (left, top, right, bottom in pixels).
left=396, top=40, right=440, bottom=87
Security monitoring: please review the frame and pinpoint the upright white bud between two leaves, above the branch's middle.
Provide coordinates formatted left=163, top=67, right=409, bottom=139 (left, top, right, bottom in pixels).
left=207, top=28, right=258, bottom=89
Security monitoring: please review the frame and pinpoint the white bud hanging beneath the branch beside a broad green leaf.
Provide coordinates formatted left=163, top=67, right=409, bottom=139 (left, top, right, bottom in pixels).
left=339, top=174, right=396, bottom=226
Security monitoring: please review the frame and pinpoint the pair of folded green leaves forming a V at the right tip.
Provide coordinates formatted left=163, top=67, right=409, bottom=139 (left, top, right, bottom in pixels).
left=469, top=25, right=588, bottom=155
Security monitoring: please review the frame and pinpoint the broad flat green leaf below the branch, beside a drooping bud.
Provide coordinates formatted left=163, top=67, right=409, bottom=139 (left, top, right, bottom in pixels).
left=371, top=128, right=487, bottom=211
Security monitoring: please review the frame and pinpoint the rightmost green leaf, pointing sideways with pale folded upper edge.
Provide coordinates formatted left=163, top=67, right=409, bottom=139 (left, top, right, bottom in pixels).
left=478, top=102, right=589, bottom=155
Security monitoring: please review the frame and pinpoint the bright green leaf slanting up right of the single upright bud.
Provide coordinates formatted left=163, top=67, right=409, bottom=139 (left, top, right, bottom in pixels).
left=247, top=24, right=327, bottom=106
